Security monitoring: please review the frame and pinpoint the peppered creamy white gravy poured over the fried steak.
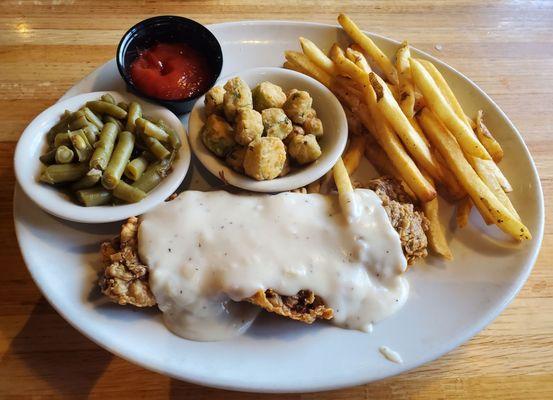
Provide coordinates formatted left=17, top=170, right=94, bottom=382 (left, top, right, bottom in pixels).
left=138, top=189, right=409, bottom=340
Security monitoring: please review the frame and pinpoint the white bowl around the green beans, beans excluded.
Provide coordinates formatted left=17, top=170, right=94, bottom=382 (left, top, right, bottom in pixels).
left=14, top=91, right=190, bottom=223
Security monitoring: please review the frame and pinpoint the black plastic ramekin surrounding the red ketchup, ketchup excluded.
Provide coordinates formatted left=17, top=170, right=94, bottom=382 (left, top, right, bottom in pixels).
left=116, top=15, right=223, bottom=114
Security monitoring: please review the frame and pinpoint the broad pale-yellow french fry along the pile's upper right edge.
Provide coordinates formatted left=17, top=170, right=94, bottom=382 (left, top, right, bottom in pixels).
left=410, top=58, right=491, bottom=160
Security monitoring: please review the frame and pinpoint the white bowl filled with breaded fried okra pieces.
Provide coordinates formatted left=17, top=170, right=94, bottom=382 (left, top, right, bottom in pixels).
left=188, top=68, right=347, bottom=193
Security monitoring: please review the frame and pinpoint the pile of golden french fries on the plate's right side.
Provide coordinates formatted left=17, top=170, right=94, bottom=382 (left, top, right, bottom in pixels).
left=284, top=14, right=531, bottom=259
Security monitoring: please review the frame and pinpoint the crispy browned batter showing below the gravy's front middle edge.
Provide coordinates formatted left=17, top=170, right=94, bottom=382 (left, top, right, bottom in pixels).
left=246, top=289, right=334, bottom=324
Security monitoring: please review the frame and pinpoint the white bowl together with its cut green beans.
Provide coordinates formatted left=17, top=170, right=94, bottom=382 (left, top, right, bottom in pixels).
left=14, top=92, right=190, bottom=223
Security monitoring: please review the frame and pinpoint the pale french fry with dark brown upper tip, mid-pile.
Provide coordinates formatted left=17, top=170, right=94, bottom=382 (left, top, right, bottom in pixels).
left=369, top=72, right=443, bottom=182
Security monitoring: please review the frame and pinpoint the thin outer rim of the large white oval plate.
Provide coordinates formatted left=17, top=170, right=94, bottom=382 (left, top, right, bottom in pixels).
left=13, top=20, right=545, bottom=393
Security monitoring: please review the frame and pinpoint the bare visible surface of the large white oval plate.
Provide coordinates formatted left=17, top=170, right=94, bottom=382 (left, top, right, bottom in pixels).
left=14, top=21, right=544, bottom=392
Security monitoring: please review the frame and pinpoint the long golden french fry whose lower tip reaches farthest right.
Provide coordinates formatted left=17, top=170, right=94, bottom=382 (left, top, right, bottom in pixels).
left=418, top=108, right=532, bottom=240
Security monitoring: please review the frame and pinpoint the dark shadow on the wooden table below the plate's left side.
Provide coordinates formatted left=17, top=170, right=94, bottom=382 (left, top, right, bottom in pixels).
left=0, top=298, right=113, bottom=398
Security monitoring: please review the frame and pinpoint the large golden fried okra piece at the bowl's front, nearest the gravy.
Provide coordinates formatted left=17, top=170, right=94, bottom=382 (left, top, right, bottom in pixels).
left=244, top=136, right=286, bottom=181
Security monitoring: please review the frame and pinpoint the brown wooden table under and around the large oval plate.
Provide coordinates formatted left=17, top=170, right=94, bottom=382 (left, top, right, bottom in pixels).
left=0, top=0, right=553, bottom=399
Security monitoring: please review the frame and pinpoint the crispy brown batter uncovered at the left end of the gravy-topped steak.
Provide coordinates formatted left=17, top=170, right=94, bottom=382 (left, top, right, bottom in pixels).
left=98, top=217, right=156, bottom=307
